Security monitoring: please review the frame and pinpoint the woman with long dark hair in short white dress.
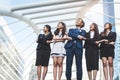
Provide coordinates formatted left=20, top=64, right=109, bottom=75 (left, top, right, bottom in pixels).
left=51, top=22, right=66, bottom=80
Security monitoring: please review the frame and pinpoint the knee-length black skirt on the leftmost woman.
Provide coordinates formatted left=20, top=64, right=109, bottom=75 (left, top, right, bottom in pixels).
left=35, top=49, right=50, bottom=66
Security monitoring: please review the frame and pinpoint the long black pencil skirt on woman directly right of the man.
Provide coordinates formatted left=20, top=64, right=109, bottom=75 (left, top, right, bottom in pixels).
left=85, top=47, right=99, bottom=71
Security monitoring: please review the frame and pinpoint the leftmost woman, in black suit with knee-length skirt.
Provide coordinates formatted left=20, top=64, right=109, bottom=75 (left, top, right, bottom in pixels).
left=36, top=25, right=53, bottom=80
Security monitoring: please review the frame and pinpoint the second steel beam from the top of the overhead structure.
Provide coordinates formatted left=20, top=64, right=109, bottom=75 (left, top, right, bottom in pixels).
left=22, top=2, right=86, bottom=15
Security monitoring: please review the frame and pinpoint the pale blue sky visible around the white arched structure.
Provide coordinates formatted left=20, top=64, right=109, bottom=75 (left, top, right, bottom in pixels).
left=0, top=0, right=120, bottom=80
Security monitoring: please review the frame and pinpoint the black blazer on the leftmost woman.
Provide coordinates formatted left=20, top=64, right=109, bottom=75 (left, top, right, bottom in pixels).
left=37, top=33, right=53, bottom=50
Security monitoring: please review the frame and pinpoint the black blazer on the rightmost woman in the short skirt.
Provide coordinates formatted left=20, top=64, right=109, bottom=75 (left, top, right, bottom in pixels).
left=100, top=31, right=116, bottom=48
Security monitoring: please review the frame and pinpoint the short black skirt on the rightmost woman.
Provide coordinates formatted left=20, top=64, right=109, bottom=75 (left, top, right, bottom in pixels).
left=100, top=45, right=115, bottom=59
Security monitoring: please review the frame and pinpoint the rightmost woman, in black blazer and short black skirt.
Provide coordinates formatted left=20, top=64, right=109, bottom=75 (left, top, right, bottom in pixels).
left=100, top=23, right=116, bottom=80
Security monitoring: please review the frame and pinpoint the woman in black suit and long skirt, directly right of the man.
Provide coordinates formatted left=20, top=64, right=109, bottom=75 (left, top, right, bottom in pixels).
left=84, top=23, right=100, bottom=80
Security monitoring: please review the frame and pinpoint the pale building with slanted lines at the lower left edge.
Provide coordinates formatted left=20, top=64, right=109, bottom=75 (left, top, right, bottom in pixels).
left=0, top=18, right=24, bottom=80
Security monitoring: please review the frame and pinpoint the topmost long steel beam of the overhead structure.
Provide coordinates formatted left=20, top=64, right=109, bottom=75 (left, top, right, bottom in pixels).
left=11, top=0, right=85, bottom=11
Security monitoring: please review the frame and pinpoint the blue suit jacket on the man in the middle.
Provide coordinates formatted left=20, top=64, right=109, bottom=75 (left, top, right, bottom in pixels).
left=65, top=28, right=86, bottom=49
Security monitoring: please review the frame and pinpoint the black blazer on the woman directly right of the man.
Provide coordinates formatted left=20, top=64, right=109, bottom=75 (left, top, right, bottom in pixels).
left=84, top=32, right=100, bottom=49
